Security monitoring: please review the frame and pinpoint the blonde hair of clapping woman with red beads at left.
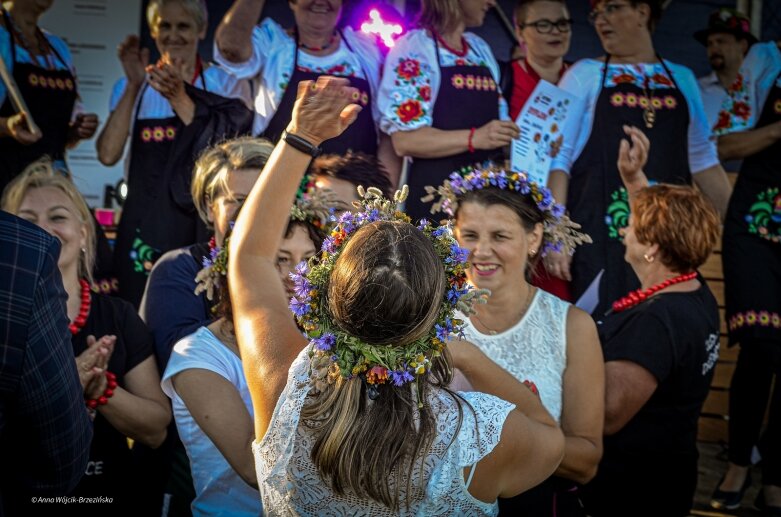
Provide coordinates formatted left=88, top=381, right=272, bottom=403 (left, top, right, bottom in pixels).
left=0, top=157, right=96, bottom=283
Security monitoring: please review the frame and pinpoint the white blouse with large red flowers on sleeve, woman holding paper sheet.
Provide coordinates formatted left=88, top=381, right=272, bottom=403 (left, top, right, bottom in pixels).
left=379, top=29, right=509, bottom=135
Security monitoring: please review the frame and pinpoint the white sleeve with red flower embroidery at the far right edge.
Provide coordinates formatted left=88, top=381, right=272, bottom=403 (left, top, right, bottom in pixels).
left=714, top=41, right=781, bottom=135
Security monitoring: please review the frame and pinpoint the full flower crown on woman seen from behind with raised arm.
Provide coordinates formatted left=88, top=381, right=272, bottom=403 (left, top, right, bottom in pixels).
left=290, top=186, right=487, bottom=404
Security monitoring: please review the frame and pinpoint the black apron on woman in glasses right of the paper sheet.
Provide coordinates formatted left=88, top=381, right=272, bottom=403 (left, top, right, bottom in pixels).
left=567, top=56, right=691, bottom=315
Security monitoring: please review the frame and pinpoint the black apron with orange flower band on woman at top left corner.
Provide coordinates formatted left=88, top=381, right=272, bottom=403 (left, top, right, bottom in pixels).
left=0, top=10, right=78, bottom=192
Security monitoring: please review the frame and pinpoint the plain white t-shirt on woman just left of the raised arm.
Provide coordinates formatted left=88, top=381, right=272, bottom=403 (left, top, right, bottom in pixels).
left=160, top=327, right=262, bottom=516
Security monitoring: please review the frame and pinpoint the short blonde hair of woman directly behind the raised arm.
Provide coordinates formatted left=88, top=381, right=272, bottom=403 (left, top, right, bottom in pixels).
left=190, top=136, right=274, bottom=225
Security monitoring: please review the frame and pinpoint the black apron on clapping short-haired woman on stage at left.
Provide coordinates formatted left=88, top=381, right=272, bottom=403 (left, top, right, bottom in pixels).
left=114, top=68, right=206, bottom=308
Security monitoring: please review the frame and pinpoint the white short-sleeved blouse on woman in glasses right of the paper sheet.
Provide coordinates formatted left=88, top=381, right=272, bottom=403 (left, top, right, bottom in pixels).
left=551, top=59, right=719, bottom=174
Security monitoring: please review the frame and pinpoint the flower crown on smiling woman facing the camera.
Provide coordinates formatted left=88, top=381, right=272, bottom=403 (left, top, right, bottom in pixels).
left=422, top=168, right=592, bottom=256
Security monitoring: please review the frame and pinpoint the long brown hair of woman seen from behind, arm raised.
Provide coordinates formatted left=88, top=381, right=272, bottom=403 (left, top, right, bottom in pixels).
left=301, top=221, right=463, bottom=510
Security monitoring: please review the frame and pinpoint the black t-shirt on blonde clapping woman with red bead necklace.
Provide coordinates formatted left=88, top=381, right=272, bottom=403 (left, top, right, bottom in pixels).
left=71, top=293, right=154, bottom=512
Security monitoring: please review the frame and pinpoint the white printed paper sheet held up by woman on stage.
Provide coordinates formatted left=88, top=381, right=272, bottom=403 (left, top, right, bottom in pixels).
left=510, top=81, right=583, bottom=185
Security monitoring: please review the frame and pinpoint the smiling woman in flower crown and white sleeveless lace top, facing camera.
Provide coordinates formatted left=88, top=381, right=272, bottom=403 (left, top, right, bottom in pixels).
left=427, top=169, right=604, bottom=517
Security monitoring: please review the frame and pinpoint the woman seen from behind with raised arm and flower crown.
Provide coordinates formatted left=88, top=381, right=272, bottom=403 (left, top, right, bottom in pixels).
left=228, top=77, right=564, bottom=515
